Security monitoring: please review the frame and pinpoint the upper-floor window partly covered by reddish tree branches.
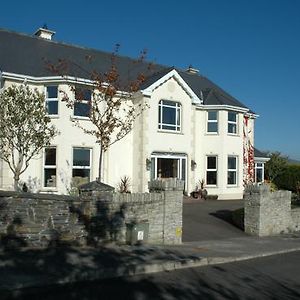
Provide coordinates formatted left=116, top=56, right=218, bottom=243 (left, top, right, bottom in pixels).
left=74, top=87, right=92, bottom=117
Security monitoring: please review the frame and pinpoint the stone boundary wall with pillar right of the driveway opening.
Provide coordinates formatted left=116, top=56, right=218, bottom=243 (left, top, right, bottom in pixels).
left=244, top=185, right=300, bottom=236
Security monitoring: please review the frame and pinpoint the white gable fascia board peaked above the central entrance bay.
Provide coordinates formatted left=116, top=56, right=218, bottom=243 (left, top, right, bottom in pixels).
left=141, top=69, right=203, bottom=104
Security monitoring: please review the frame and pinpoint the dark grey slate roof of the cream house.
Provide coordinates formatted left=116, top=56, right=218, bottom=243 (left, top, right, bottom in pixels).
left=0, top=29, right=247, bottom=108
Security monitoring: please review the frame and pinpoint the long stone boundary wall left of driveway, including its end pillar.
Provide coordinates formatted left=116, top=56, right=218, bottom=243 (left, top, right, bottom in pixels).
left=0, top=182, right=183, bottom=246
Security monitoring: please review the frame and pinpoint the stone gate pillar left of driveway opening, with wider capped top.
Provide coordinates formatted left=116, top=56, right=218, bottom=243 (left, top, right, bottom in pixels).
left=149, top=178, right=184, bottom=244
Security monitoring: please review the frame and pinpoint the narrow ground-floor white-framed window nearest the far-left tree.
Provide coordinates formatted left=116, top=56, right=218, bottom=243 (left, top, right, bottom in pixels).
left=43, top=147, right=56, bottom=188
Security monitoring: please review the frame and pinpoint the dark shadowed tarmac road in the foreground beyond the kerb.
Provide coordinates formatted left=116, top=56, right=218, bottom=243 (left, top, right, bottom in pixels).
left=5, top=251, right=300, bottom=300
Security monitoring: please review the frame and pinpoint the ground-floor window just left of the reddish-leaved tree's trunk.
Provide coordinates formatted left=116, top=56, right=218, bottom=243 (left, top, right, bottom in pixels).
left=72, top=147, right=92, bottom=182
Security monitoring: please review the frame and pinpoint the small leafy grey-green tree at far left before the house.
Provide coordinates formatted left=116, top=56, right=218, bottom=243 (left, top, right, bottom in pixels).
left=0, top=84, right=58, bottom=190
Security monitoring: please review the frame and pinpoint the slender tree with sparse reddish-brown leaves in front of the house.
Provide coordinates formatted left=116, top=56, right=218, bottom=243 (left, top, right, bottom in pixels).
left=46, top=45, right=151, bottom=182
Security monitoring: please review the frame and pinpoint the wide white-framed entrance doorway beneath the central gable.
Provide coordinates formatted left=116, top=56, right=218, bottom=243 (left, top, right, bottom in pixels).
left=151, top=153, right=186, bottom=185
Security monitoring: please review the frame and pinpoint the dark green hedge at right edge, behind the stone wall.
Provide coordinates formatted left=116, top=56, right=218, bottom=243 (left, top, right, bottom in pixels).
left=274, top=165, right=300, bottom=193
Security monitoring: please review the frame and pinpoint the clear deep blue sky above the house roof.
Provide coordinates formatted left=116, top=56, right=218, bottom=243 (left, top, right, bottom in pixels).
left=0, top=0, right=300, bottom=160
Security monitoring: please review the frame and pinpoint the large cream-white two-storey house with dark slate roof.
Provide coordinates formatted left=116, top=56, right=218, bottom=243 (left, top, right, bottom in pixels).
left=0, top=28, right=266, bottom=199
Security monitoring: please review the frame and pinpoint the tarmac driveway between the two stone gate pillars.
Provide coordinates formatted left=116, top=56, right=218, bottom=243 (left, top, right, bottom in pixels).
left=182, top=200, right=246, bottom=242
